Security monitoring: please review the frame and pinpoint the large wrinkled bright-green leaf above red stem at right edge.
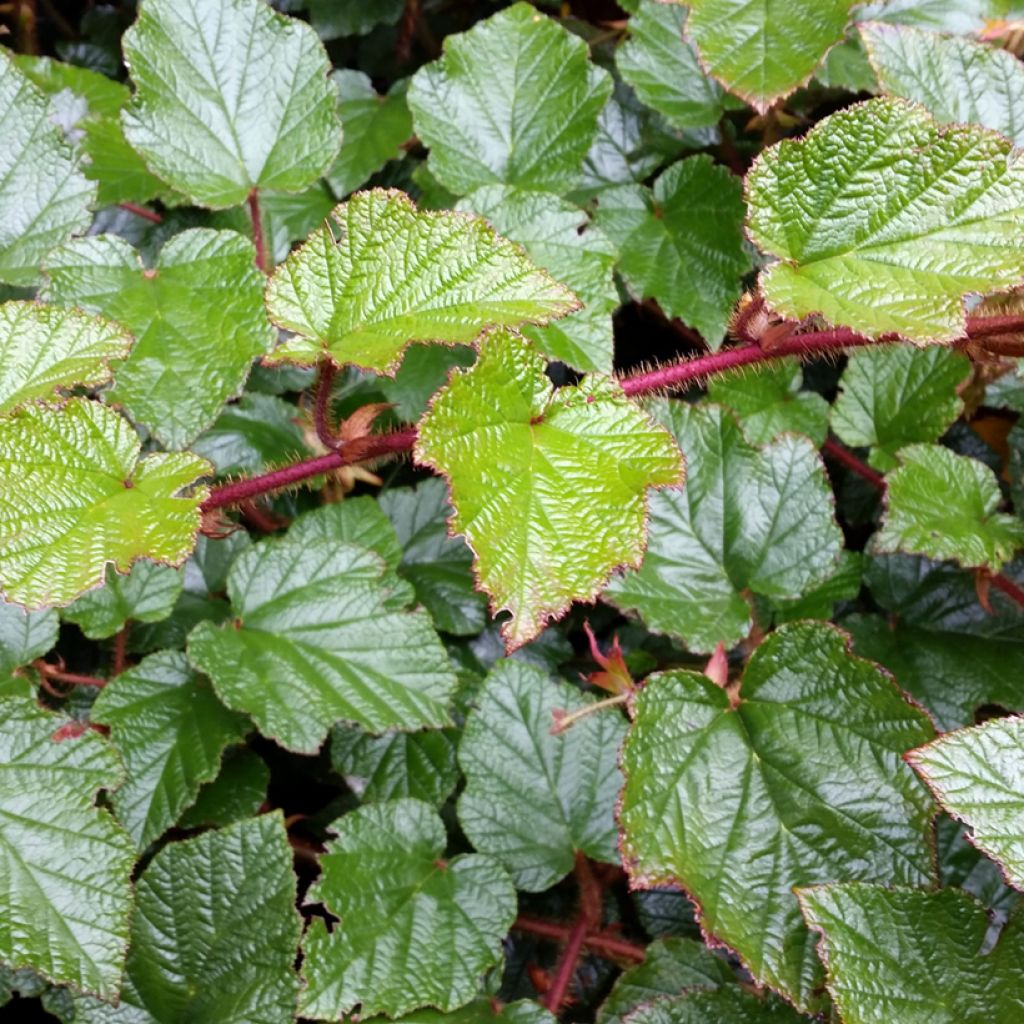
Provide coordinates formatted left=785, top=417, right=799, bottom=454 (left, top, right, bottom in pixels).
left=746, top=99, right=1024, bottom=344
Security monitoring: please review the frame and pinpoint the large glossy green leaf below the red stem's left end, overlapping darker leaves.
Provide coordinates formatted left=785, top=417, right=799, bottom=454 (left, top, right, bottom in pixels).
left=188, top=532, right=456, bottom=754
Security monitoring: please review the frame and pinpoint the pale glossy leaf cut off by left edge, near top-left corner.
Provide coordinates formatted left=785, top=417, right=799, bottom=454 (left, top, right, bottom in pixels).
left=0, top=49, right=96, bottom=288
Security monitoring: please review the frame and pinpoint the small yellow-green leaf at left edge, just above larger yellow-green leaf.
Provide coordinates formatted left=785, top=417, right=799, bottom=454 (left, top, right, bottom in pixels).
left=0, top=302, right=132, bottom=415
